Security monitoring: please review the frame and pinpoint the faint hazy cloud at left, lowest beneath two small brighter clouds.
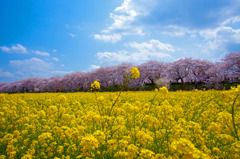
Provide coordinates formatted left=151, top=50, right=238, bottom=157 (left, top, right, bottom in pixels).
left=9, top=57, right=53, bottom=72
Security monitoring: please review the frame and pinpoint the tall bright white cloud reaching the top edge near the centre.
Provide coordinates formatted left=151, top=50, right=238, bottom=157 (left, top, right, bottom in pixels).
left=94, top=0, right=155, bottom=43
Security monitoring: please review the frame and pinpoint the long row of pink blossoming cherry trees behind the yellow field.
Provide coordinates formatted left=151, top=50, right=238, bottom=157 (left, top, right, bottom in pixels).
left=0, top=52, right=240, bottom=92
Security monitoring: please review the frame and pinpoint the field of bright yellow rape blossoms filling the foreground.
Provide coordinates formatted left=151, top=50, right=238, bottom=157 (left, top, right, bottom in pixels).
left=0, top=87, right=240, bottom=159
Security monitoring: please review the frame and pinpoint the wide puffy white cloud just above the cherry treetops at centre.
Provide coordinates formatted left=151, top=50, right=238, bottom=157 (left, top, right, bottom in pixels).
left=97, top=39, right=175, bottom=63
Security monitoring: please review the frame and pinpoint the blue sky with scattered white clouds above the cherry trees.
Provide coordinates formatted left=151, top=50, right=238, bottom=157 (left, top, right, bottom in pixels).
left=0, top=0, right=240, bottom=82
